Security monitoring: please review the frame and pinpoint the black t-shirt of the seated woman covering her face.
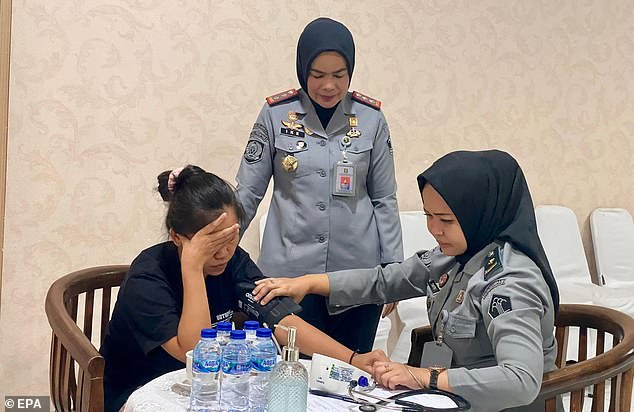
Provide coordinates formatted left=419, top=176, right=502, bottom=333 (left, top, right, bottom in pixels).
left=100, top=242, right=301, bottom=411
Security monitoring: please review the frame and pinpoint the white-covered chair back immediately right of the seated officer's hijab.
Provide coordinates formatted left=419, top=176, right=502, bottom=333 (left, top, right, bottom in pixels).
left=535, top=205, right=592, bottom=283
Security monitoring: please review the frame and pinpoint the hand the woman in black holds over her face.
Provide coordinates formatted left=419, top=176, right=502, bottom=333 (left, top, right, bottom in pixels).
left=175, top=213, right=240, bottom=272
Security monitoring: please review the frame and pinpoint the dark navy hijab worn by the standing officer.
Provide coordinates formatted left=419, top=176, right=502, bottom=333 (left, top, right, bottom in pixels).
left=297, top=17, right=354, bottom=129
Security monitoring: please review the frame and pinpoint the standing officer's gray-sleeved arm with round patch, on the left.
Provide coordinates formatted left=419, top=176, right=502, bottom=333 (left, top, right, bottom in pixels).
left=236, top=104, right=275, bottom=234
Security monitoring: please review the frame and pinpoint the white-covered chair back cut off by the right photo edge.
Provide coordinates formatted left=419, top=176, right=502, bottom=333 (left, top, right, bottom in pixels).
left=590, top=208, right=634, bottom=287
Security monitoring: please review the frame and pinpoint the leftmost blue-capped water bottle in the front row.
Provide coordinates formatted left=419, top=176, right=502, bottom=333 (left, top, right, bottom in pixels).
left=189, top=329, right=221, bottom=412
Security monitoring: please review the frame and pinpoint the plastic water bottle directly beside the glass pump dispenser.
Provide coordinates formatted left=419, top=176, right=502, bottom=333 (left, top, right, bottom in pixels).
left=249, top=328, right=277, bottom=412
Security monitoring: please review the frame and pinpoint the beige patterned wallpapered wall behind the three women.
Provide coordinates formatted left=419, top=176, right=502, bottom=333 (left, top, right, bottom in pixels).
left=0, top=0, right=634, bottom=399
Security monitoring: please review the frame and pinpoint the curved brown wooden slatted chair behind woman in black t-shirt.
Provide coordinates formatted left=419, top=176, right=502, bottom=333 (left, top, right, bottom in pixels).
left=45, top=265, right=129, bottom=412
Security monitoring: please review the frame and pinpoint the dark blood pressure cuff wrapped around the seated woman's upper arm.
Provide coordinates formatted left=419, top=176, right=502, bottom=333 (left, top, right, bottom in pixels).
left=236, top=281, right=302, bottom=330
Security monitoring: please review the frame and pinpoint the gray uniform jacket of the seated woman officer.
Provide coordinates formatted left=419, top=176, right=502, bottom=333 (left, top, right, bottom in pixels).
left=328, top=243, right=557, bottom=411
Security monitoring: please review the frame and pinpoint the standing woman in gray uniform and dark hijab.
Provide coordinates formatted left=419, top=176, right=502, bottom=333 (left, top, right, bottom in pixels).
left=236, top=18, right=403, bottom=352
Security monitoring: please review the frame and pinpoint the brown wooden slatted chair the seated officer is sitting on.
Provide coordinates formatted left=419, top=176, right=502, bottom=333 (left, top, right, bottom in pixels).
left=408, top=304, right=634, bottom=412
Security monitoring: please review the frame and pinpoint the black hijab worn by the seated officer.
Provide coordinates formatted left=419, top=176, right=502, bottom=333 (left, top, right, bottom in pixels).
left=417, top=150, right=559, bottom=311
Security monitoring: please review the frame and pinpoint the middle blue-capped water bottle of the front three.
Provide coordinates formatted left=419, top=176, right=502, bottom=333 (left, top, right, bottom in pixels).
left=220, top=330, right=251, bottom=411
